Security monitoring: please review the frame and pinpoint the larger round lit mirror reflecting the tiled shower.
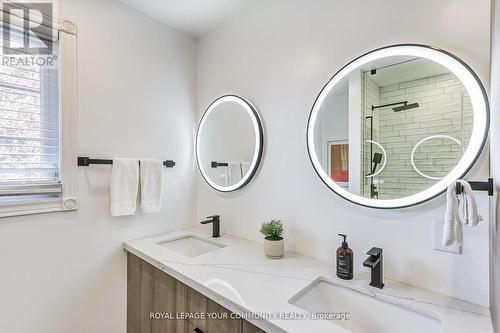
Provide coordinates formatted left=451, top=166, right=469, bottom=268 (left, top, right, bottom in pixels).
left=307, top=45, right=489, bottom=208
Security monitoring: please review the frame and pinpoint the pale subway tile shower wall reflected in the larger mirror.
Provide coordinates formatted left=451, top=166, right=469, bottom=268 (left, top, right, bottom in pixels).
left=377, top=73, right=473, bottom=199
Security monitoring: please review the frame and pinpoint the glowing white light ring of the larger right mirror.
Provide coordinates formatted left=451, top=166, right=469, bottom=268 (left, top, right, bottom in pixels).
left=306, top=44, right=490, bottom=209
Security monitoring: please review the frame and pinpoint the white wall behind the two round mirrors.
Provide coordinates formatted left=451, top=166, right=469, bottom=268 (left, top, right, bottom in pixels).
left=197, top=0, right=490, bottom=305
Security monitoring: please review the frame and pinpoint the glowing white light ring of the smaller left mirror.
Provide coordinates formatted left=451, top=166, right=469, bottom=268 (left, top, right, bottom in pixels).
left=195, top=95, right=264, bottom=192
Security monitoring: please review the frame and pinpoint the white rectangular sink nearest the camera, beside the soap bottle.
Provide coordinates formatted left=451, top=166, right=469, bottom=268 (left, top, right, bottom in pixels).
left=289, top=278, right=441, bottom=333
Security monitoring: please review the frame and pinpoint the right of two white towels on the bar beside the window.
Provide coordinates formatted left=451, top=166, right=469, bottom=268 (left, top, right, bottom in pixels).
left=141, top=160, right=164, bottom=213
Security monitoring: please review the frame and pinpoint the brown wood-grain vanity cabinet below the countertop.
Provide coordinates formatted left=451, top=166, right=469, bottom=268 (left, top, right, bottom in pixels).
left=127, top=253, right=264, bottom=333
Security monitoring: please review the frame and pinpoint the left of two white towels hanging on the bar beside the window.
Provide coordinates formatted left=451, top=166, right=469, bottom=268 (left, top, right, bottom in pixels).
left=110, top=158, right=139, bottom=216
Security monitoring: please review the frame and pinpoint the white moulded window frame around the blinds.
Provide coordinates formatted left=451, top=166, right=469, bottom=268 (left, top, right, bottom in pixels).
left=0, top=20, right=78, bottom=218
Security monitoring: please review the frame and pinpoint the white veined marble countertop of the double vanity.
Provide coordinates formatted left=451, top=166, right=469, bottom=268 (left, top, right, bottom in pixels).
left=124, top=227, right=493, bottom=333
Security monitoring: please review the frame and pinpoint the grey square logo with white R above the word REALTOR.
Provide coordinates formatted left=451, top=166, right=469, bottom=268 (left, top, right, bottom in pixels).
left=2, top=2, right=54, bottom=55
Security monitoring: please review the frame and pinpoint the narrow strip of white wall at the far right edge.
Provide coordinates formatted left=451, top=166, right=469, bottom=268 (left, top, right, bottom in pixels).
left=490, top=0, right=500, bottom=332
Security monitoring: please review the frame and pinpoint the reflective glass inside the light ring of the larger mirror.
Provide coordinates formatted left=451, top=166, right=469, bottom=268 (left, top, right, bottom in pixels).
left=314, top=56, right=473, bottom=199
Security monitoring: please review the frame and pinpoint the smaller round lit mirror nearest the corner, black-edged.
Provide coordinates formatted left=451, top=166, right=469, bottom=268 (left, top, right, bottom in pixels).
left=196, top=95, right=263, bottom=192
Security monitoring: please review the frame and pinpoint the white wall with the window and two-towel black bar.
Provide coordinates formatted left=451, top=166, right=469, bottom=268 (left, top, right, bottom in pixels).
left=0, top=0, right=196, bottom=333
